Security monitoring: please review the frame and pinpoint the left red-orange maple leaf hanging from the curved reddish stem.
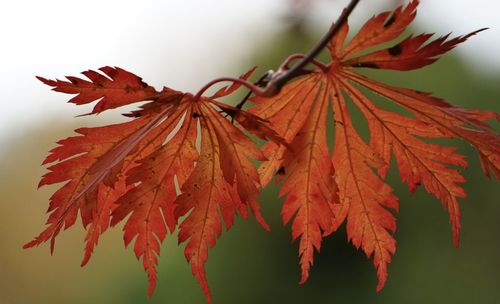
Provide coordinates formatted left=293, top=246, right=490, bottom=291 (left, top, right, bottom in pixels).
left=24, top=67, right=278, bottom=301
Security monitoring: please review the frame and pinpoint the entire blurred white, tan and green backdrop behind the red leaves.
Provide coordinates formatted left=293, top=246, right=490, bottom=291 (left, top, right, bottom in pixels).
left=0, top=0, right=500, bottom=304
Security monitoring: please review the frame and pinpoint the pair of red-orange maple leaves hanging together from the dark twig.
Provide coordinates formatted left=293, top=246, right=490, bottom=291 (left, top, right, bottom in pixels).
left=25, top=0, right=500, bottom=301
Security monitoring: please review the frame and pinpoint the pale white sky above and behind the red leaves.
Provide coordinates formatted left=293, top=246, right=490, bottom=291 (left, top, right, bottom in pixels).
left=0, top=0, right=500, bottom=145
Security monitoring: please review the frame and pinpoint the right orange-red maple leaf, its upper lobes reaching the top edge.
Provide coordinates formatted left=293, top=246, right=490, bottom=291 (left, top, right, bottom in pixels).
left=250, top=0, right=500, bottom=290
